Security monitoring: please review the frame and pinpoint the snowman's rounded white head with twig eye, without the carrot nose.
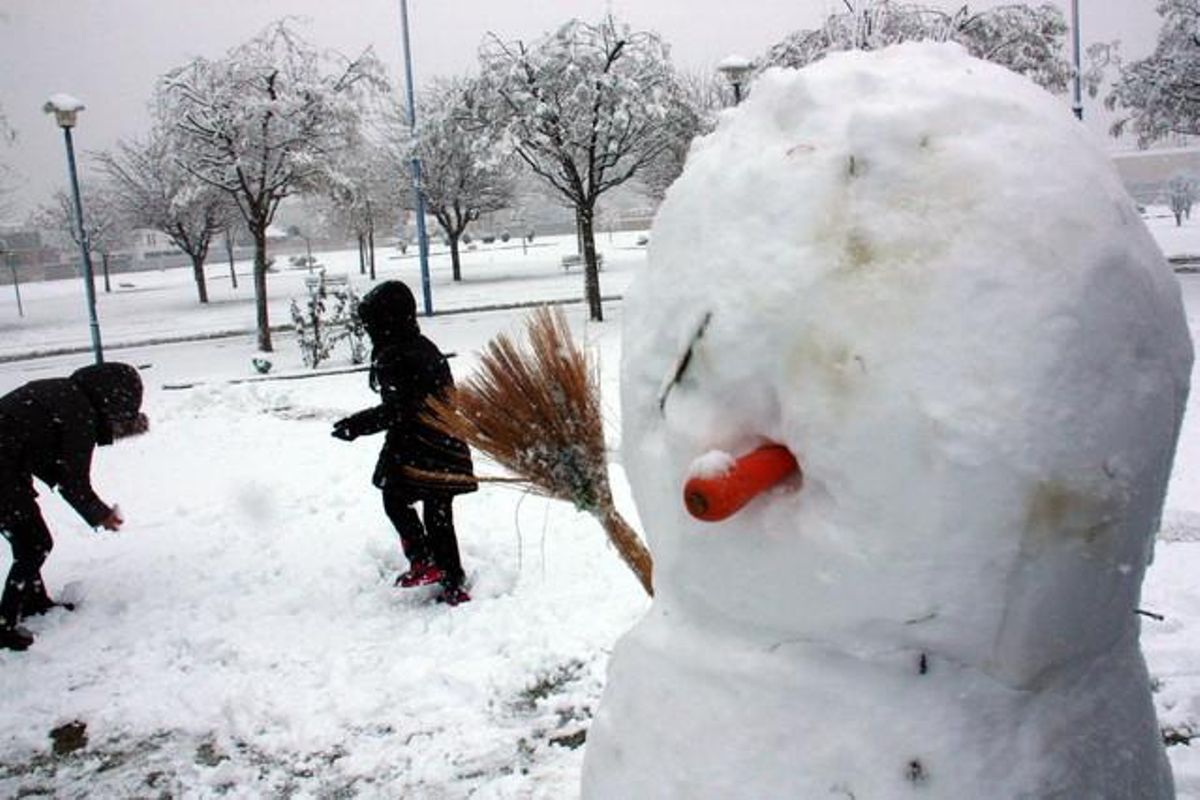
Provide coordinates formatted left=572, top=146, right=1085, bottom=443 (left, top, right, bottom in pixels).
left=622, top=44, right=1192, bottom=673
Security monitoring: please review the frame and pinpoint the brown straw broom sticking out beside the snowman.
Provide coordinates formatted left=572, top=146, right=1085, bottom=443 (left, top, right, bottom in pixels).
left=427, top=306, right=654, bottom=595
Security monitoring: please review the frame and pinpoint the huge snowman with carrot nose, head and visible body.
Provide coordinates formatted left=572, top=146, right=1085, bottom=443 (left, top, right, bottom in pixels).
left=583, top=43, right=1192, bottom=800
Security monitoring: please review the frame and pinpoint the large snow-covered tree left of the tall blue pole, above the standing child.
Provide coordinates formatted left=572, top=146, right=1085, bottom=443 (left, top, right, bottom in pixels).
left=160, top=20, right=382, bottom=351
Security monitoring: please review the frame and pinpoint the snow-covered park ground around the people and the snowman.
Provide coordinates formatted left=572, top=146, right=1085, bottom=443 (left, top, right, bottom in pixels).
left=0, top=219, right=1200, bottom=800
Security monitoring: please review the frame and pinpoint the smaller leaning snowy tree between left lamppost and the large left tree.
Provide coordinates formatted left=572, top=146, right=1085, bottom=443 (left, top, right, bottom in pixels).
left=97, top=127, right=228, bottom=303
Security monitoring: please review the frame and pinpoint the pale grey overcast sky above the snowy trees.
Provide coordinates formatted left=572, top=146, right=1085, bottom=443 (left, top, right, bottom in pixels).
left=0, top=0, right=1159, bottom=220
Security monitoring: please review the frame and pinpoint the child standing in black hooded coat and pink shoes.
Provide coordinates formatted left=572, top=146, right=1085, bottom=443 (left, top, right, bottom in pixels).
left=334, top=281, right=478, bottom=606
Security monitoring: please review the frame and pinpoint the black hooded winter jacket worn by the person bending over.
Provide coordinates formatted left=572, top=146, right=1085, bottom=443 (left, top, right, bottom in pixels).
left=0, top=362, right=142, bottom=528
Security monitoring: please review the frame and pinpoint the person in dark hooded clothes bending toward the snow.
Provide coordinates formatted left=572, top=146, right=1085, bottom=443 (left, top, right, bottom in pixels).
left=0, top=363, right=146, bottom=650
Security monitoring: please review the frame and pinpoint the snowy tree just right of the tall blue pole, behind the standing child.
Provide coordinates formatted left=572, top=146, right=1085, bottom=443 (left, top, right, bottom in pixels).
left=397, top=78, right=515, bottom=281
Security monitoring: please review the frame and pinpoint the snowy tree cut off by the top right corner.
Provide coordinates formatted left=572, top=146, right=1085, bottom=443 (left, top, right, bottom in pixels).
left=1104, top=0, right=1200, bottom=146
